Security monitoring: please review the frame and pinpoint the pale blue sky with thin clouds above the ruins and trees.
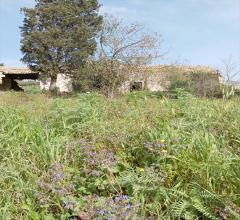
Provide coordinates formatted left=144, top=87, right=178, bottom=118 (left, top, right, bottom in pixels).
left=0, top=0, right=240, bottom=67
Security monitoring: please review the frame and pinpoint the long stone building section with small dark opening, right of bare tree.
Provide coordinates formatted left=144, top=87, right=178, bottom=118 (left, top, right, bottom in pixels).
left=120, top=65, right=224, bottom=92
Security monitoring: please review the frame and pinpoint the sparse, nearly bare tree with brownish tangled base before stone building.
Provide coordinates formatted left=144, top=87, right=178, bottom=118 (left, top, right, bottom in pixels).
left=83, top=16, right=164, bottom=97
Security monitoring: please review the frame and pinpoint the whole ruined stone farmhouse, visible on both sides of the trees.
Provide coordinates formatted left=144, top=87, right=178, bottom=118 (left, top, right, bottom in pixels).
left=0, top=65, right=224, bottom=93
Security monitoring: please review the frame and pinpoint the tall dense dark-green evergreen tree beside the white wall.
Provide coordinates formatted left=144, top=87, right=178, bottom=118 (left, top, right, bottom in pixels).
left=21, top=0, right=102, bottom=90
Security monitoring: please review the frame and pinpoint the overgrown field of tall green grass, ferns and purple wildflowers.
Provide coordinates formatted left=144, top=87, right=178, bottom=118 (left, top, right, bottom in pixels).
left=0, top=93, right=240, bottom=220
